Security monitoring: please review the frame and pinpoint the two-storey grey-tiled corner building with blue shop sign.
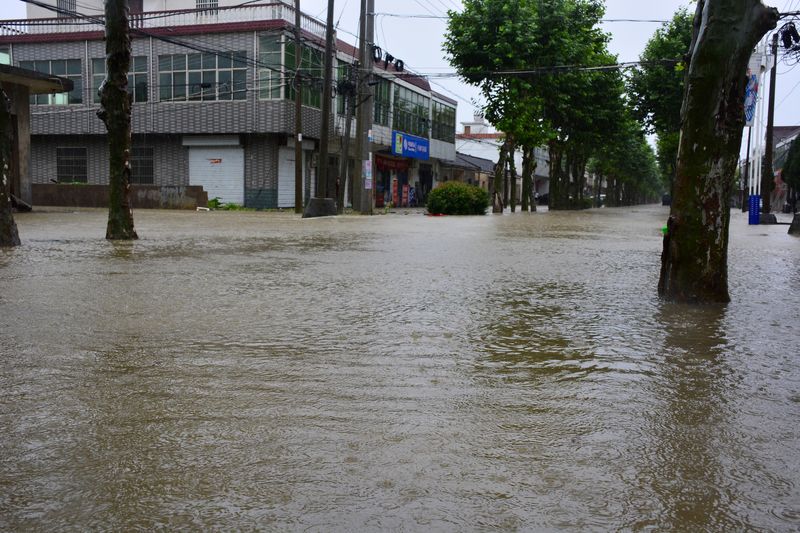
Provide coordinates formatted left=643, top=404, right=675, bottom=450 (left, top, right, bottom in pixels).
left=0, top=0, right=456, bottom=208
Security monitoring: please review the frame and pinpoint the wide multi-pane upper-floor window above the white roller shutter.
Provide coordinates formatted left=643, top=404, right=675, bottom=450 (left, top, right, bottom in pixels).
left=158, top=51, right=247, bottom=102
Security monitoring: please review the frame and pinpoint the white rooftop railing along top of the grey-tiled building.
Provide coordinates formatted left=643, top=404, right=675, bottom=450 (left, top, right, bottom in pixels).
left=0, top=2, right=325, bottom=37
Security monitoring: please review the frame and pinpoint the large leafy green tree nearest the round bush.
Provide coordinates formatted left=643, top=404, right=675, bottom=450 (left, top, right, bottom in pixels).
left=445, top=0, right=616, bottom=212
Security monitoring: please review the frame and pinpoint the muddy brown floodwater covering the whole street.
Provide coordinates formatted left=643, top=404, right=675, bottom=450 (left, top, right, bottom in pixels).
left=0, top=206, right=800, bottom=531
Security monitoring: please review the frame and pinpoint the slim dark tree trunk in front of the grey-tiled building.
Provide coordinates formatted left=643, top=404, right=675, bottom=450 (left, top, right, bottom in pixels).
left=97, top=0, right=138, bottom=240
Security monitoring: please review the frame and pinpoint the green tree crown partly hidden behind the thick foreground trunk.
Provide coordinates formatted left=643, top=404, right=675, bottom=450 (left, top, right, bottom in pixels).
left=628, top=9, right=693, bottom=190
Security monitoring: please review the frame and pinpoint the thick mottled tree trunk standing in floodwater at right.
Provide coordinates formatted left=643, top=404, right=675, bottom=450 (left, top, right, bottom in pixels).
left=658, top=0, right=778, bottom=303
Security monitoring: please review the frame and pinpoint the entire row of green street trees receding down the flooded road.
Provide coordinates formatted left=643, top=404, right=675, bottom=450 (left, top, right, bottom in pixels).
left=445, top=0, right=668, bottom=212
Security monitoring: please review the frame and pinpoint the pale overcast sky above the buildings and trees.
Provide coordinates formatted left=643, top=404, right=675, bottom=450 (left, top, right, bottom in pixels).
left=6, top=0, right=800, bottom=129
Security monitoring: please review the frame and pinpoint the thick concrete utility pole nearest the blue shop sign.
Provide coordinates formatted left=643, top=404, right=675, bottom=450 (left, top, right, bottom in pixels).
left=353, top=0, right=375, bottom=215
